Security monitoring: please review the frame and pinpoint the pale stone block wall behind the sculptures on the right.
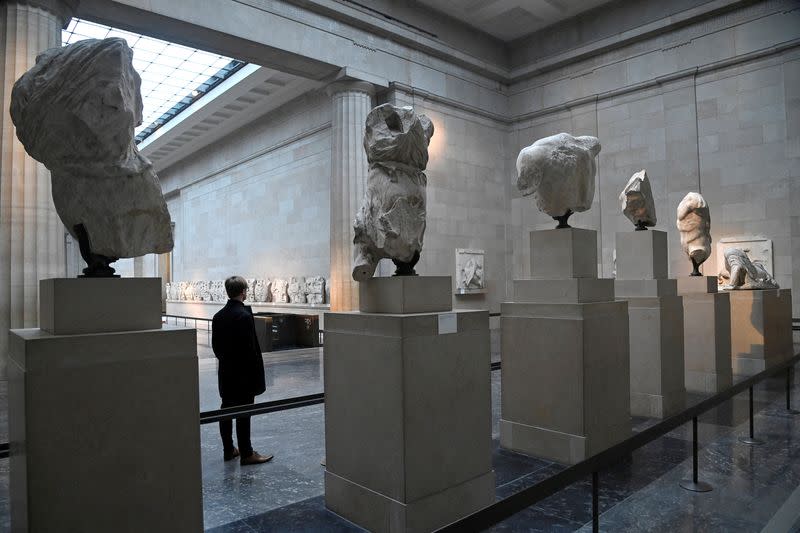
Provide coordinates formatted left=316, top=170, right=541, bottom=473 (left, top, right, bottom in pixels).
left=509, top=1, right=800, bottom=316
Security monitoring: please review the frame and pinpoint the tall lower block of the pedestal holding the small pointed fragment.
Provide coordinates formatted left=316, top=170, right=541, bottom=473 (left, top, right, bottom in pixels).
left=627, top=296, right=686, bottom=418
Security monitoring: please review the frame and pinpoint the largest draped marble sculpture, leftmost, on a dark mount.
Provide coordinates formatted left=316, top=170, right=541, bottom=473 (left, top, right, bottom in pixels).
left=11, top=38, right=173, bottom=276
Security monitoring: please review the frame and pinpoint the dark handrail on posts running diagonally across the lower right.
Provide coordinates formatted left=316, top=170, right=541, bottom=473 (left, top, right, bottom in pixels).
left=436, top=353, right=800, bottom=533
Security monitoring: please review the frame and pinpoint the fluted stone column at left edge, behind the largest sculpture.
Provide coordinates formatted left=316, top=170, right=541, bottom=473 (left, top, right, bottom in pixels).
left=0, top=0, right=77, bottom=379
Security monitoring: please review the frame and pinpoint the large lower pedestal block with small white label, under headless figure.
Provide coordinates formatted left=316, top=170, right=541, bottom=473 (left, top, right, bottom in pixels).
left=325, top=310, right=494, bottom=531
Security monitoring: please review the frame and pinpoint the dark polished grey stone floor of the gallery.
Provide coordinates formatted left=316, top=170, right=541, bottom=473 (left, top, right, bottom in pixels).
left=0, top=335, right=800, bottom=533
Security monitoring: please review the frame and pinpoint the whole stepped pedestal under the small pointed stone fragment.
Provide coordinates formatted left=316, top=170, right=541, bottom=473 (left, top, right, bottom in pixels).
left=615, top=230, right=686, bottom=418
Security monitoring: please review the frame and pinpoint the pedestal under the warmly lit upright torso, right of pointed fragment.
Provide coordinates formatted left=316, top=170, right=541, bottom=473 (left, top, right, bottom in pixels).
left=678, top=276, right=733, bottom=393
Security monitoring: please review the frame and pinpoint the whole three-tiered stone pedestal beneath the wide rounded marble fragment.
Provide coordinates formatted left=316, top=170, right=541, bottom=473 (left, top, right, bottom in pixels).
left=500, top=228, right=631, bottom=463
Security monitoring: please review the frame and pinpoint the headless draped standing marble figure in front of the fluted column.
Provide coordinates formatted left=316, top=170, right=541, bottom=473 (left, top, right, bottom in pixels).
left=353, top=104, right=433, bottom=281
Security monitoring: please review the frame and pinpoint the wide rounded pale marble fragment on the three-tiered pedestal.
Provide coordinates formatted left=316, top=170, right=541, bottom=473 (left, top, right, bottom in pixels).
left=517, top=133, right=600, bottom=228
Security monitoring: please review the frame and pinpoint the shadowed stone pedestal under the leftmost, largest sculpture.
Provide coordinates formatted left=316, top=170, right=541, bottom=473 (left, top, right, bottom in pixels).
left=9, top=278, right=203, bottom=532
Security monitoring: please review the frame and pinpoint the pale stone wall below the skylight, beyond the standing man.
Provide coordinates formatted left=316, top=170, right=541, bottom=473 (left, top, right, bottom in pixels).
left=160, top=91, right=331, bottom=280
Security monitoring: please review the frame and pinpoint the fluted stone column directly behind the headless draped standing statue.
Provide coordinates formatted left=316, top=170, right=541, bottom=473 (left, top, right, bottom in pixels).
left=328, top=81, right=375, bottom=311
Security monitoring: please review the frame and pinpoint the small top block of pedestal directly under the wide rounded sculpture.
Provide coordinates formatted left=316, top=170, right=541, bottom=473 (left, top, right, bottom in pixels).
left=530, top=228, right=597, bottom=279
